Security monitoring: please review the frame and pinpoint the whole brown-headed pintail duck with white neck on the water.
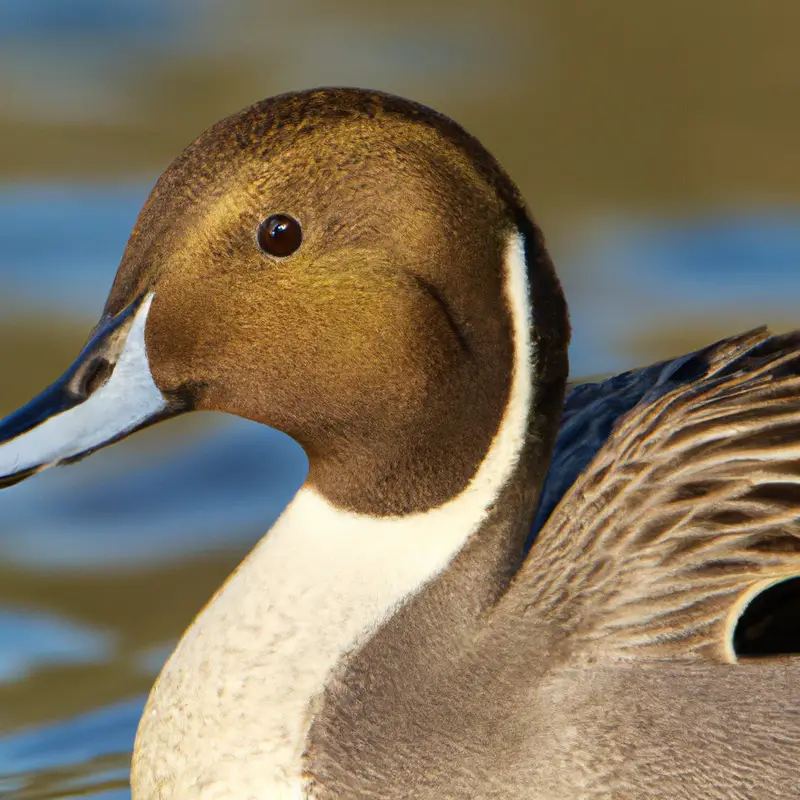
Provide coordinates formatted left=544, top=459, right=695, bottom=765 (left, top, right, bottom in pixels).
left=0, top=89, right=800, bottom=800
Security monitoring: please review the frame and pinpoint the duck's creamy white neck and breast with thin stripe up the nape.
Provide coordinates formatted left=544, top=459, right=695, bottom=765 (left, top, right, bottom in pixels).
left=132, top=231, right=534, bottom=798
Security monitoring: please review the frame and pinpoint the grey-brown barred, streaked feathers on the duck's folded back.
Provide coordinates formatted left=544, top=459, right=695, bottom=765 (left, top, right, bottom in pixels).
left=517, top=330, right=800, bottom=661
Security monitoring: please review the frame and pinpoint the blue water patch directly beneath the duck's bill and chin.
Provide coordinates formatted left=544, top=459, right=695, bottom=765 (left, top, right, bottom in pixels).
left=0, top=415, right=306, bottom=573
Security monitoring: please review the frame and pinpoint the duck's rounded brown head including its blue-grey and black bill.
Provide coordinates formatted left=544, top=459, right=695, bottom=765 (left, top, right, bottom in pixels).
left=0, top=89, right=568, bottom=515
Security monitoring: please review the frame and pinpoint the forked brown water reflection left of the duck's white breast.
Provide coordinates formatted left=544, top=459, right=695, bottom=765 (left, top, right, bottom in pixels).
left=0, top=552, right=242, bottom=734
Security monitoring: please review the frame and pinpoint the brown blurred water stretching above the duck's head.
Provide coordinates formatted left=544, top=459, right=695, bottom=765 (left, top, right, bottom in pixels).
left=0, top=0, right=800, bottom=217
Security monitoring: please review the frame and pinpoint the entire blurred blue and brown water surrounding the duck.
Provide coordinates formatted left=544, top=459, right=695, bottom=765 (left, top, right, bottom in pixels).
left=0, top=0, right=800, bottom=800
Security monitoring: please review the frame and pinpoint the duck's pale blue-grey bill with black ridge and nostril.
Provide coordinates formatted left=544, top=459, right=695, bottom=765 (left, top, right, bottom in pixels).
left=0, top=293, right=175, bottom=487
